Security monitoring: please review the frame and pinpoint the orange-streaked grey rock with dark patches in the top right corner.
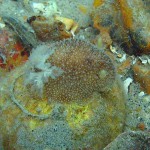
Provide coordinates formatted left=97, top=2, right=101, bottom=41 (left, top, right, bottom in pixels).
left=91, top=0, right=150, bottom=55
